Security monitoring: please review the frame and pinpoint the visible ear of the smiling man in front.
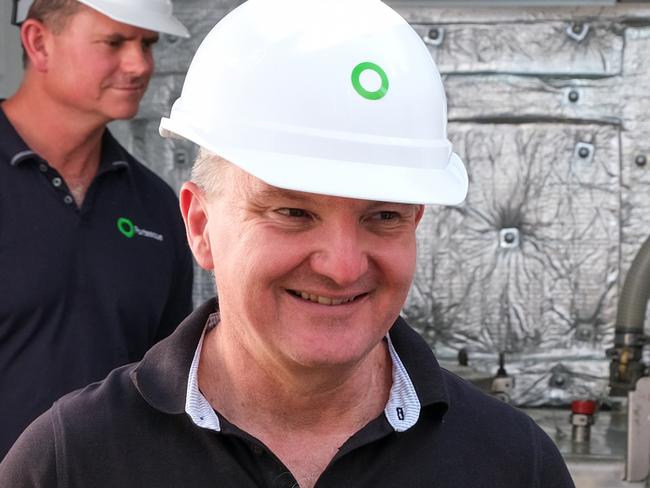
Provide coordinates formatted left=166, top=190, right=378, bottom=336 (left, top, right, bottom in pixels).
left=179, top=181, right=214, bottom=270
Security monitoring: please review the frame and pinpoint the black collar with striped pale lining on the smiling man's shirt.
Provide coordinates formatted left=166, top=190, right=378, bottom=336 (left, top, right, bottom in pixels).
left=131, top=299, right=449, bottom=426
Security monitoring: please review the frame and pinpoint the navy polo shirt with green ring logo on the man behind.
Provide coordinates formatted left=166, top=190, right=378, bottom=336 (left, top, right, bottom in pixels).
left=0, top=108, right=192, bottom=459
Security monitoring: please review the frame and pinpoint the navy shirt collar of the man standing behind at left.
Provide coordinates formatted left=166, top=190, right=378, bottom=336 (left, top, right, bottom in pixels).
left=0, top=99, right=130, bottom=171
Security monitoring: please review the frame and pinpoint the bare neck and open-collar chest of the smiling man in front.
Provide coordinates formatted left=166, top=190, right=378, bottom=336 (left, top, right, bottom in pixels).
left=198, top=325, right=392, bottom=488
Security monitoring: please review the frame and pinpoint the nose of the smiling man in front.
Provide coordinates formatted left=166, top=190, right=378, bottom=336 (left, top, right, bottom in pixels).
left=310, top=223, right=368, bottom=287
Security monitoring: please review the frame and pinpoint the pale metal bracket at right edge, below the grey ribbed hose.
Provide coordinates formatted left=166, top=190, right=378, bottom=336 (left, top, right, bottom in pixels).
left=625, top=377, right=650, bottom=481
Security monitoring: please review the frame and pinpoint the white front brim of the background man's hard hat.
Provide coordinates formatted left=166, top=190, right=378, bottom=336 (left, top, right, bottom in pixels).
left=79, top=0, right=190, bottom=37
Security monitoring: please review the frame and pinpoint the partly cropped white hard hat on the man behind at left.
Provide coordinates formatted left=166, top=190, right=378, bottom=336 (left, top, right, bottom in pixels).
left=14, top=0, right=190, bottom=37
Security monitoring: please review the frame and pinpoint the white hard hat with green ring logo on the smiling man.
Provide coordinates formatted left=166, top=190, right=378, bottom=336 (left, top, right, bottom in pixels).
left=160, top=0, right=468, bottom=204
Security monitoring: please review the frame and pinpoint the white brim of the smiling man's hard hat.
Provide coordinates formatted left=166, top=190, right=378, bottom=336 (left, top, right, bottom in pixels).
left=160, top=118, right=468, bottom=205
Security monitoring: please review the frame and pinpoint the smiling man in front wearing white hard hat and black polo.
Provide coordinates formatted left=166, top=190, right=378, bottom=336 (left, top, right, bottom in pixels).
left=0, top=0, right=573, bottom=488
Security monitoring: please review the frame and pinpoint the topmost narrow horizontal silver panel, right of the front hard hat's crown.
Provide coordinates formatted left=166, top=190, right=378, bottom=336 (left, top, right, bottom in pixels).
left=413, top=21, right=623, bottom=76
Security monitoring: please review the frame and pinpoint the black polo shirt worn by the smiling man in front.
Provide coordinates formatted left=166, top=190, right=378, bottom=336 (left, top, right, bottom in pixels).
left=0, top=301, right=574, bottom=488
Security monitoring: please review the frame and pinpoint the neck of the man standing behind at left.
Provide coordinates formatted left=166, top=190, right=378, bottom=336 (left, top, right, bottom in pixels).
left=2, top=84, right=106, bottom=203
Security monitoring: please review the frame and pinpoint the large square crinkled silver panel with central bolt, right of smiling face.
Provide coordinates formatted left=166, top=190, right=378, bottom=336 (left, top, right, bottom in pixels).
left=405, top=123, right=620, bottom=404
